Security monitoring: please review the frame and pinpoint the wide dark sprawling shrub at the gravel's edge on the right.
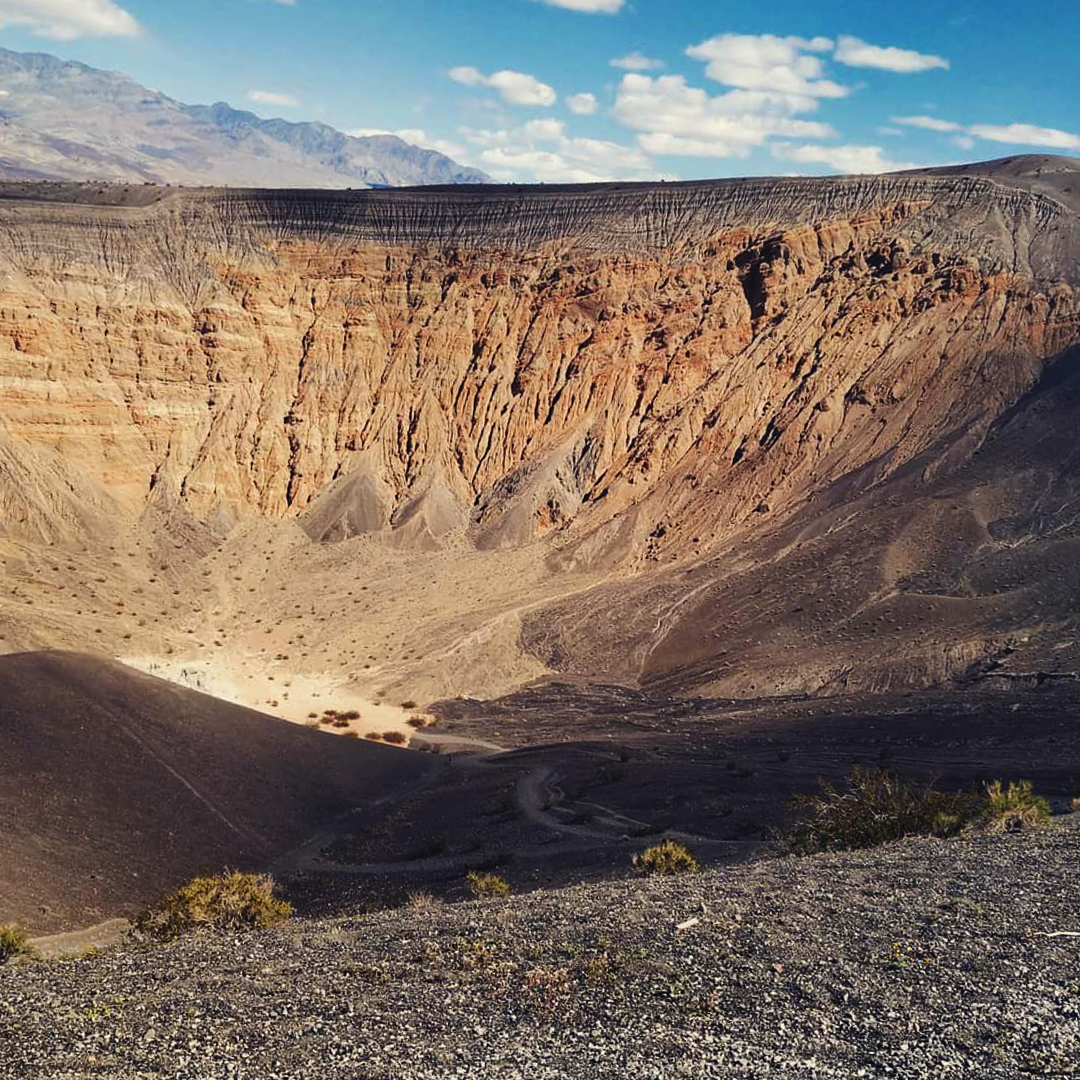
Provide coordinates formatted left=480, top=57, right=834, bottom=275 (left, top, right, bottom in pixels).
left=786, top=767, right=985, bottom=853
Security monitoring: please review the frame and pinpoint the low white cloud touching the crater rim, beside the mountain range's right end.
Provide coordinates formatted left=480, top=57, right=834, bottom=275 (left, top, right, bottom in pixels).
left=461, top=120, right=657, bottom=184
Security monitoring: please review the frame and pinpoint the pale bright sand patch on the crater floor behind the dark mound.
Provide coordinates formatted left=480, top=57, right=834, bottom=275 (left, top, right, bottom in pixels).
left=118, top=656, right=416, bottom=735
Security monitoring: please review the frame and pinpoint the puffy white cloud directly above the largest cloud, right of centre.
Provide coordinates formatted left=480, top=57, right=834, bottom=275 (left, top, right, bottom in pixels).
left=686, top=33, right=850, bottom=112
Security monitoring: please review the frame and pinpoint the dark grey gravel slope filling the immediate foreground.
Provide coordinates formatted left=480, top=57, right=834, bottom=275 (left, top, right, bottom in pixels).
left=0, top=813, right=1080, bottom=1080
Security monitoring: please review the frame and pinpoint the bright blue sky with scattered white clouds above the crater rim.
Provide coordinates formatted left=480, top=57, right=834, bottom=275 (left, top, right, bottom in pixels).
left=0, top=0, right=1080, bottom=181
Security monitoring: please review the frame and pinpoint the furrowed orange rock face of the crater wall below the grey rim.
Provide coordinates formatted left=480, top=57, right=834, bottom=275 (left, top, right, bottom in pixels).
left=0, top=173, right=1080, bottom=558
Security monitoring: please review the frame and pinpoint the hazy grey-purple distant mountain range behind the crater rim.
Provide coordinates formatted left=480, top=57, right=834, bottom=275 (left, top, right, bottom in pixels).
left=0, top=49, right=489, bottom=188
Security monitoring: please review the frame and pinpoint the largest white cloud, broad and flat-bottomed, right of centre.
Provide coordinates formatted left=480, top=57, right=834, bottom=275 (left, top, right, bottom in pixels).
left=615, top=75, right=836, bottom=158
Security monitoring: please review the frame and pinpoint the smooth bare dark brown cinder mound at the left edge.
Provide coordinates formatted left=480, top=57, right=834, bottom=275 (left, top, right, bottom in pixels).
left=0, top=652, right=433, bottom=932
